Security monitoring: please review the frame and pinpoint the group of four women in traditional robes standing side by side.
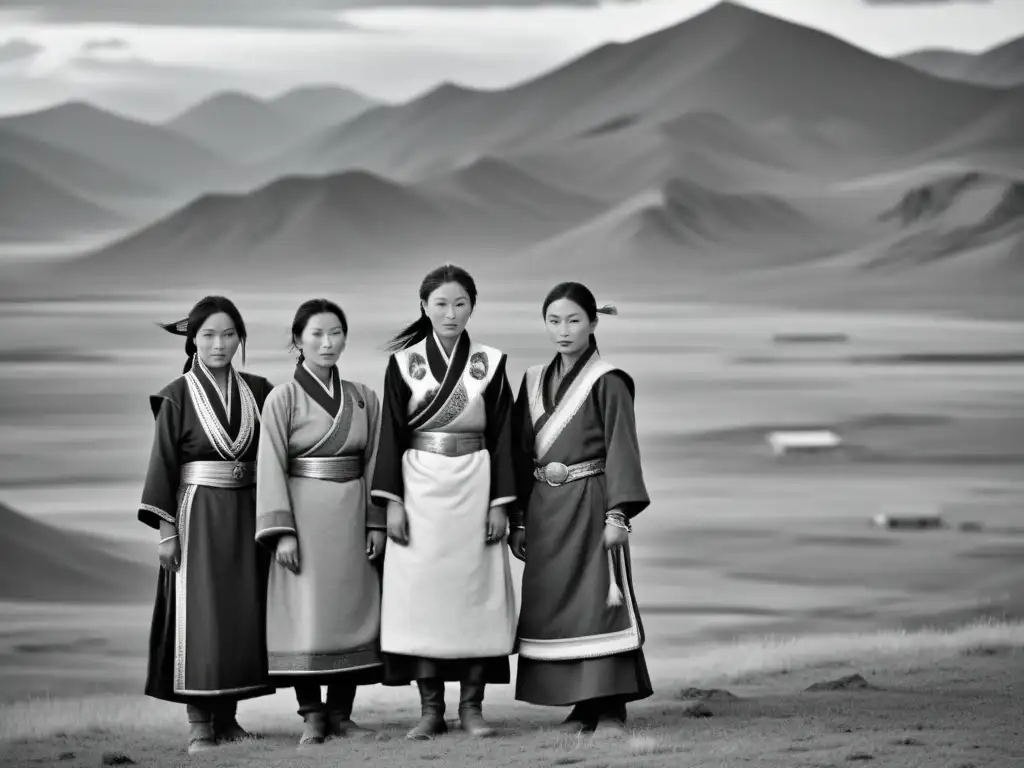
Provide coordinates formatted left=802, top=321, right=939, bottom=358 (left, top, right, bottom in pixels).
left=138, top=265, right=652, bottom=753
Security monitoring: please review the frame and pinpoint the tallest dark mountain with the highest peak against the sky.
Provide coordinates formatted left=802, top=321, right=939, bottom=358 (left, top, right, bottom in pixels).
left=263, top=3, right=1000, bottom=181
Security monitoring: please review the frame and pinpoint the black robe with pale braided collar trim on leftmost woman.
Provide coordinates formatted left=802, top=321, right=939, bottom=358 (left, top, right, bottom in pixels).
left=138, top=355, right=273, bottom=707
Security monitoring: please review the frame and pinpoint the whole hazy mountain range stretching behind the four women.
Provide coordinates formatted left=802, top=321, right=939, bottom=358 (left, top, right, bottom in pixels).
left=0, top=2, right=1024, bottom=315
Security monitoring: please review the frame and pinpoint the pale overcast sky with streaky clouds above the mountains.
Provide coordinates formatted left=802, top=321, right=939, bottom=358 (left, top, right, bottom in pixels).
left=0, top=0, right=1024, bottom=119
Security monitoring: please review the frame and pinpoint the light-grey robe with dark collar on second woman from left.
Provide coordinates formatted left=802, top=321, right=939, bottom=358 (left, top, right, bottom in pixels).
left=256, top=364, right=385, bottom=685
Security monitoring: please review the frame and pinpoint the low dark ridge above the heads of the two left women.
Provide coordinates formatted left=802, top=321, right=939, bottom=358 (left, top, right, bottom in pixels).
left=62, top=171, right=528, bottom=283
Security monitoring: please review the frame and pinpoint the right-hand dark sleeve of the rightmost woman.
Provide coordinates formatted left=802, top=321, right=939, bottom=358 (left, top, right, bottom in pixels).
left=595, top=372, right=650, bottom=517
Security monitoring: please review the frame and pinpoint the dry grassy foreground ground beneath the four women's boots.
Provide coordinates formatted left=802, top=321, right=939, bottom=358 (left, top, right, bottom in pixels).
left=0, top=622, right=1024, bottom=768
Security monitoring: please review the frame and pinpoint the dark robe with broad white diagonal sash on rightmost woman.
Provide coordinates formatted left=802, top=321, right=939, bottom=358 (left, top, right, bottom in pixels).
left=513, top=346, right=652, bottom=706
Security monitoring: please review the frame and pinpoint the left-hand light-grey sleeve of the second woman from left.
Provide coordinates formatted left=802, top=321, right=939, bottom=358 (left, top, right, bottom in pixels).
left=256, top=385, right=297, bottom=547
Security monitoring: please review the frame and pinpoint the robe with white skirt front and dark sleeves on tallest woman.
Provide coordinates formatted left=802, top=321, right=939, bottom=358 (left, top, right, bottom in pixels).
left=372, top=333, right=515, bottom=685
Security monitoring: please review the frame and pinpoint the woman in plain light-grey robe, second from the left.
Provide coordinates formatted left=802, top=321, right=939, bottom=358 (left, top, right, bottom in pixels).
left=256, top=299, right=385, bottom=744
